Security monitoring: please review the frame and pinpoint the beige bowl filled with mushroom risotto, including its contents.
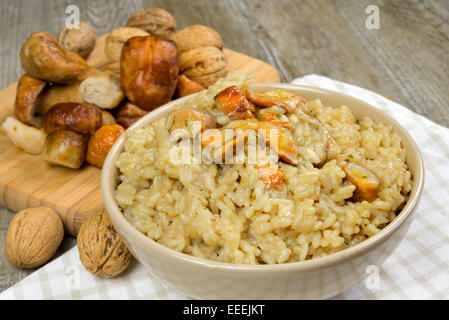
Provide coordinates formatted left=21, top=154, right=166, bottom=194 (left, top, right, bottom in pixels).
left=102, top=73, right=424, bottom=299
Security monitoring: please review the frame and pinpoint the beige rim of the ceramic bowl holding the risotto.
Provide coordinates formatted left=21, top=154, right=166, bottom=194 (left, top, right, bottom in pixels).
left=101, top=83, right=425, bottom=273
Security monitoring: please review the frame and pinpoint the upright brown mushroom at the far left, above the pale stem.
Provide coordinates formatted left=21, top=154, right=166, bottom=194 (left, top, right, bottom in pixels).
left=14, top=74, right=46, bottom=128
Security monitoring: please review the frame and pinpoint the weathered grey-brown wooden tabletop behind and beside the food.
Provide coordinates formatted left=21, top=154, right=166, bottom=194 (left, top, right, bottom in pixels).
left=0, top=0, right=449, bottom=291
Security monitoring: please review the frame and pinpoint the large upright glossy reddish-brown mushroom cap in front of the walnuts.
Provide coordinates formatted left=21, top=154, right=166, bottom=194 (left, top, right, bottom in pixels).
left=120, top=36, right=179, bottom=111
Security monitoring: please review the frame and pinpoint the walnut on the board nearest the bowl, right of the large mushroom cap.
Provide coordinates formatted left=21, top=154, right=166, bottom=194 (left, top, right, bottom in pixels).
left=179, top=47, right=228, bottom=88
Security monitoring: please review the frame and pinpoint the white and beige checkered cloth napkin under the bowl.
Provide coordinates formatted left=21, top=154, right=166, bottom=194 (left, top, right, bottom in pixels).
left=0, top=75, right=449, bottom=299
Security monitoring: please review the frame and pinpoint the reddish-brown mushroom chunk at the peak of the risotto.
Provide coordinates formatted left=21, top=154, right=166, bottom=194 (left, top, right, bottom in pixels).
left=214, top=86, right=254, bottom=120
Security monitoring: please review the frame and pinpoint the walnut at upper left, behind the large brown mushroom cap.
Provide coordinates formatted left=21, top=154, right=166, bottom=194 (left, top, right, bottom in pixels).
left=59, top=21, right=97, bottom=59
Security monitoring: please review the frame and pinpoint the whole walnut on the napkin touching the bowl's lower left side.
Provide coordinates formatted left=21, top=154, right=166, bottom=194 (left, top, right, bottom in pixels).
left=77, top=212, right=132, bottom=278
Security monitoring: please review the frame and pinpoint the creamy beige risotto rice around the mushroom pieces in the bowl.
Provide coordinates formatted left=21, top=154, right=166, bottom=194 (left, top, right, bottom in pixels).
left=115, top=73, right=411, bottom=264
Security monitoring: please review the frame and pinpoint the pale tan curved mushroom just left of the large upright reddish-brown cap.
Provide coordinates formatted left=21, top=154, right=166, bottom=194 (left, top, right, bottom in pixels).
left=104, top=27, right=149, bottom=62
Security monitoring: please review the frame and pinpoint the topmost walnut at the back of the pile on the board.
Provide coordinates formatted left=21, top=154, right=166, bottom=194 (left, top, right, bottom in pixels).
left=126, top=8, right=176, bottom=40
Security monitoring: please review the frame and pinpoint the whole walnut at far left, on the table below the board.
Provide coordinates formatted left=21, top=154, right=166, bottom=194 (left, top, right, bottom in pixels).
left=5, top=207, right=64, bottom=269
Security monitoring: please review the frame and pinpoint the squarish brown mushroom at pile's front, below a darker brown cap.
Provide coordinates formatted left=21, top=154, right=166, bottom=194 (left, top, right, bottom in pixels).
left=43, top=130, right=88, bottom=169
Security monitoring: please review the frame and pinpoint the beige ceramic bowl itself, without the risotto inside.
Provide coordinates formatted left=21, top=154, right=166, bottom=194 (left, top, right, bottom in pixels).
left=101, top=84, right=424, bottom=299
